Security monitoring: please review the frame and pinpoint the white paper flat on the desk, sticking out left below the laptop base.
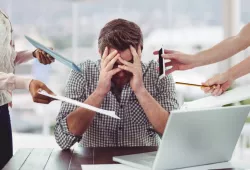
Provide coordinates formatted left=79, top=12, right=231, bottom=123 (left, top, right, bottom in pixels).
left=82, top=164, right=138, bottom=170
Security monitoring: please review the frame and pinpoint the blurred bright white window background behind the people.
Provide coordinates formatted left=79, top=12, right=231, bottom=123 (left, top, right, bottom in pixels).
left=0, top=0, right=250, bottom=159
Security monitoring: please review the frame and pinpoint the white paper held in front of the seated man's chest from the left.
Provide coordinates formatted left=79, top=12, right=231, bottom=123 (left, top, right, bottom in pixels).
left=38, top=90, right=120, bottom=119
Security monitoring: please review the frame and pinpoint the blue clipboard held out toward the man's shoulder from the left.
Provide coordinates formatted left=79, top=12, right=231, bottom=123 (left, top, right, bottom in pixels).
left=25, top=36, right=82, bottom=72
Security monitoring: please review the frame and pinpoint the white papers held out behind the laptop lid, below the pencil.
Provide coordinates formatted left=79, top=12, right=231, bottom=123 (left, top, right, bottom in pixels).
left=181, top=86, right=250, bottom=109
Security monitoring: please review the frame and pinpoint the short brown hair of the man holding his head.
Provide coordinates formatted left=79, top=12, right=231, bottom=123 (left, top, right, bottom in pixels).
left=98, top=19, right=143, bottom=53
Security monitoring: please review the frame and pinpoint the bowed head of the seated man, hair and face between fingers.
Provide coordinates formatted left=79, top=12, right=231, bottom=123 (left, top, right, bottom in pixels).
left=98, top=19, right=143, bottom=85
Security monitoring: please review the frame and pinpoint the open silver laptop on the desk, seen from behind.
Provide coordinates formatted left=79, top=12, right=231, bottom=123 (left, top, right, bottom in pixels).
left=113, top=105, right=250, bottom=170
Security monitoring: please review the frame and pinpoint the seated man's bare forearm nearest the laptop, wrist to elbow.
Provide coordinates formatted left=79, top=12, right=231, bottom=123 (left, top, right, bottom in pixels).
left=135, top=88, right=169, bottom=134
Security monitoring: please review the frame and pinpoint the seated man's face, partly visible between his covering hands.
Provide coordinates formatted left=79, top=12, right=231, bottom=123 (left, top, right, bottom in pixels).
left=109, top=48, right=133, bottom=87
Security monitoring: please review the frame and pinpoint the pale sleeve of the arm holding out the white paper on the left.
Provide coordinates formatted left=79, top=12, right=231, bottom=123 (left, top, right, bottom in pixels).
left=0, top=72, right=32, bottom=91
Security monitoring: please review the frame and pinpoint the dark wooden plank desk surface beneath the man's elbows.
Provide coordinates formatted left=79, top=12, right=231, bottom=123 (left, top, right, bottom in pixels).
left=3, top=147, right=157, bottom=170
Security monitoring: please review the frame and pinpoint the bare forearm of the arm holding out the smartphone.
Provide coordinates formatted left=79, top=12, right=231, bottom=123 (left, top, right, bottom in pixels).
left=197, top=24, right=250, bottom=66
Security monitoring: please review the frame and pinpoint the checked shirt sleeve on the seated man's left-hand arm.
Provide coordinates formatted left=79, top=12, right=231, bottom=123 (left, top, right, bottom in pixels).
left=54, top=65, right=86, bottom=149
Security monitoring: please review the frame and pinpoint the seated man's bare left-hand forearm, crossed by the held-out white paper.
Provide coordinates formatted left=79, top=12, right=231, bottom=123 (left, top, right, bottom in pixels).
left=67, top=91, right=105, bottom=136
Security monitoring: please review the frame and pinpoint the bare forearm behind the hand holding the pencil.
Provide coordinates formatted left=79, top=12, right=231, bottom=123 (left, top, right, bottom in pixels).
left=227, top=56, right=250, bottom=80
